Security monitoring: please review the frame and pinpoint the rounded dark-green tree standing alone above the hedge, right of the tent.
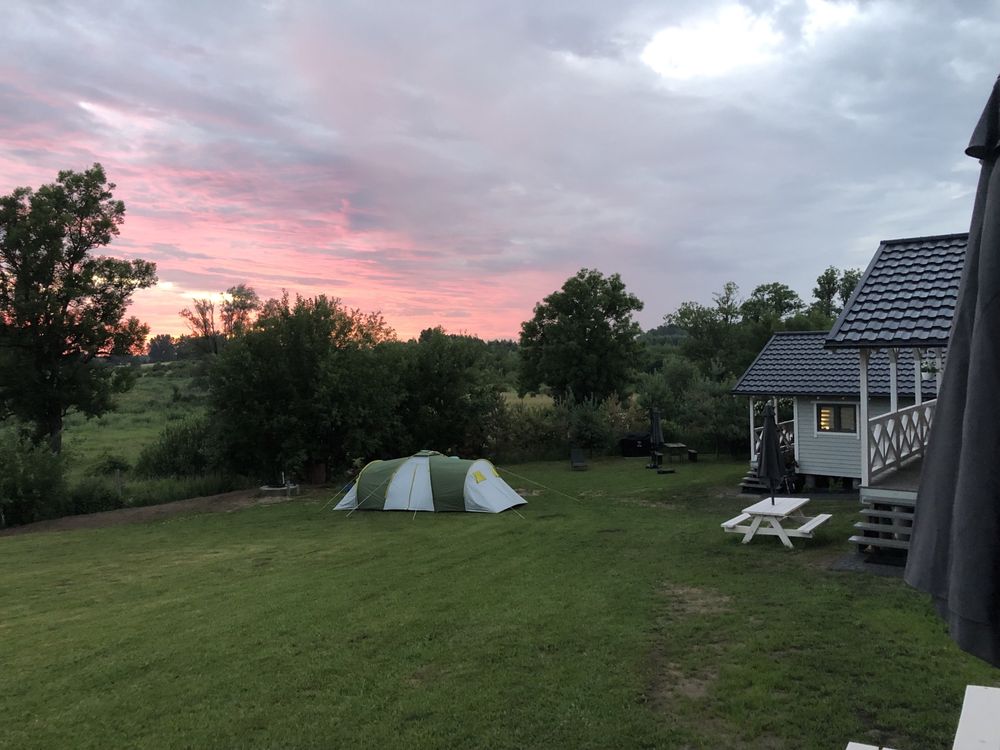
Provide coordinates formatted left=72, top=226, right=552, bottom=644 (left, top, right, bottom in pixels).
left=520, top=268, right=642, bottom=401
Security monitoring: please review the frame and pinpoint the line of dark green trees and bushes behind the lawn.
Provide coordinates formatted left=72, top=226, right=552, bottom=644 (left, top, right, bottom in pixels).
left=0, top=164, right=860, bottom=523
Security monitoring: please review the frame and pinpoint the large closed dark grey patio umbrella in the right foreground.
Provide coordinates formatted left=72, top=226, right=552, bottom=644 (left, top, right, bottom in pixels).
left=905, top=73, right=1000, bottom=666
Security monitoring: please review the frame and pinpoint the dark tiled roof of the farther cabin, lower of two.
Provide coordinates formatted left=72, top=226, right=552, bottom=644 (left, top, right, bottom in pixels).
left=733, top=331, right=935, bottom=398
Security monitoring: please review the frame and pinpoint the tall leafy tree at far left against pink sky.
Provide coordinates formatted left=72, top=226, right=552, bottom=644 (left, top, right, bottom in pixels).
left=0, top=164, right=156, bottom=453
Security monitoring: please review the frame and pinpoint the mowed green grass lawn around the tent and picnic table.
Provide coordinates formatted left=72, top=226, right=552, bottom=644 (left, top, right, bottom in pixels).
left=0, top=459, right=1000, bottom=750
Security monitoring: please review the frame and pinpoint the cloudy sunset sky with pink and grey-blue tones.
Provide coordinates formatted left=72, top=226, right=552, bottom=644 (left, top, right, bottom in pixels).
left=0, top=0, right=1000, bottom=338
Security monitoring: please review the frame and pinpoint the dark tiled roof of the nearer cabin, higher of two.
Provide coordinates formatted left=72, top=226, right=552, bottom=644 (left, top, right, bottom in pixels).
left=826, top=234, right=969, bottom=348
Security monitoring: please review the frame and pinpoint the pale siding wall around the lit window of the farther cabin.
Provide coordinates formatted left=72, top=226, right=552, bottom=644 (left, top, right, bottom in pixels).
left=795, top=398, right=903, bottom=479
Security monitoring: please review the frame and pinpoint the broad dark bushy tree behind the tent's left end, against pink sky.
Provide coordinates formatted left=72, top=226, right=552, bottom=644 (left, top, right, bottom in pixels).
left=209, top=295, right=400, bottom=482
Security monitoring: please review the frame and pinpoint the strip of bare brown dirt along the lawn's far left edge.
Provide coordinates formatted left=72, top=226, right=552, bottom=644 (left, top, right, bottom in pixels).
left=0, top=489, right=308, bottom=537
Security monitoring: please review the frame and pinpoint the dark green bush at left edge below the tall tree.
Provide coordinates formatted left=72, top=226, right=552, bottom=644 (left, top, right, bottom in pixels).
left=0, top=425, right=65, bottom=527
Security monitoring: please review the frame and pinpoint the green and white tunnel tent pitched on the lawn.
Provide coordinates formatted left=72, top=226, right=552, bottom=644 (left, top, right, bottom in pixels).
left=334, top=451, right=525, bottom=513
